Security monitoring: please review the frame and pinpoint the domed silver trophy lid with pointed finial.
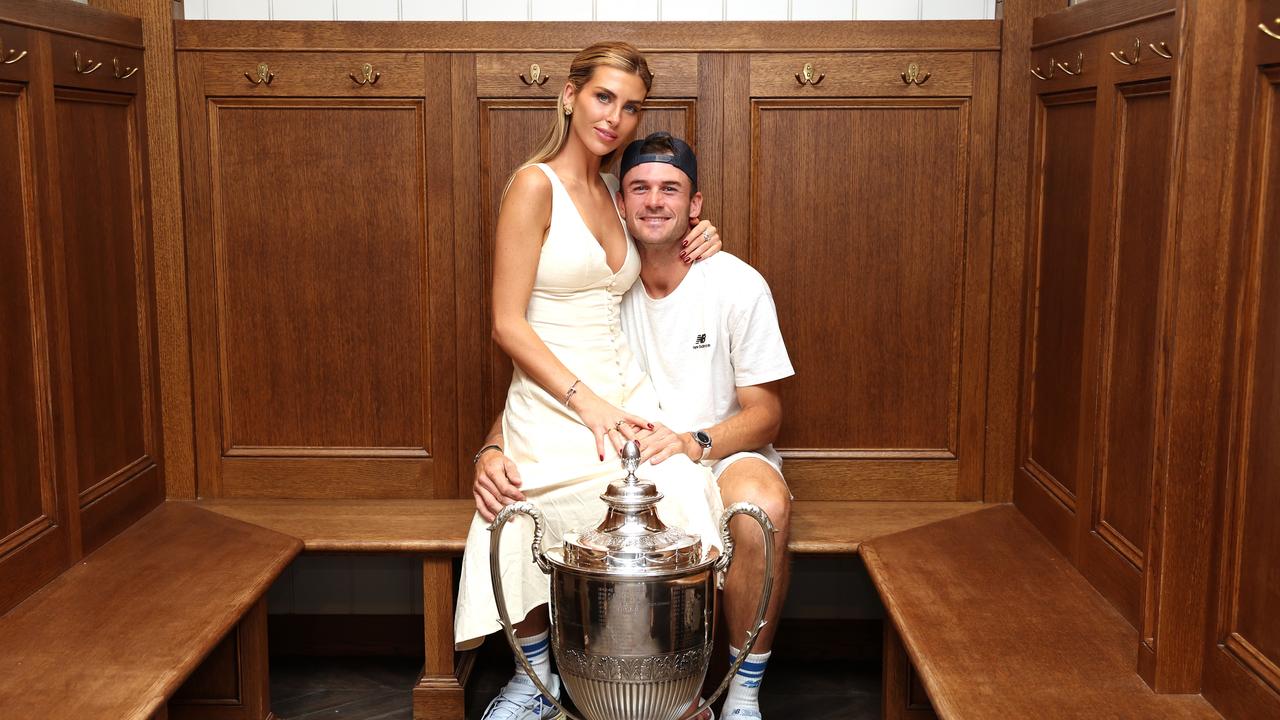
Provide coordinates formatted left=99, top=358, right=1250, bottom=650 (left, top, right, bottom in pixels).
left=562, top=441, right=703, bottom=575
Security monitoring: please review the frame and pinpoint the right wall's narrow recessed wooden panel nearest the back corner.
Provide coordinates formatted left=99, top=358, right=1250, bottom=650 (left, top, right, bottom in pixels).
left=1014, top=90, right=1097, bottom=543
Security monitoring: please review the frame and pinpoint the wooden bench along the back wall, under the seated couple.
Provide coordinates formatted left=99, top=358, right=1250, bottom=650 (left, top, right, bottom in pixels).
left=198, top=500, right=982, bottom=720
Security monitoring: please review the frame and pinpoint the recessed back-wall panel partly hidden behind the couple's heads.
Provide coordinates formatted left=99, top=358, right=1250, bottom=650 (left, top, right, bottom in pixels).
left=472, top=98, right=716, bottom=417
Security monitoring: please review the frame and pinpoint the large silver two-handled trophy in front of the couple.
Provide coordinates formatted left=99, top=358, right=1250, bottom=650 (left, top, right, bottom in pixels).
left=489, top=442, right=776, bottom=720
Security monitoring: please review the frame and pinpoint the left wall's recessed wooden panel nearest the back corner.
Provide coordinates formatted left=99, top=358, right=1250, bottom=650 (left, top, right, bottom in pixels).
left=54, top=83, right=164, bottom=552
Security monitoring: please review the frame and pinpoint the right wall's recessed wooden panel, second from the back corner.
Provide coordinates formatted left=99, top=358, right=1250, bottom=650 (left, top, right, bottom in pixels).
left=1080, top=79, right=1172, bottom=624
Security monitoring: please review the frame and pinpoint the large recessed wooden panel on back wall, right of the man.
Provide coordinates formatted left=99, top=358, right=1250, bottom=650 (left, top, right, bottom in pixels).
left=746, top=99, right=986, bottom=500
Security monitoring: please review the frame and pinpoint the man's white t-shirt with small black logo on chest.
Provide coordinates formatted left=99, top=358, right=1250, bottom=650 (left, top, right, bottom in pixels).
left=622, top=251, right=795, bottom=466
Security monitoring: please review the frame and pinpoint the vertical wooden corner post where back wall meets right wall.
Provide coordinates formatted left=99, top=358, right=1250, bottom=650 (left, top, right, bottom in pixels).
left=983, top=0, right=1085, bottom=502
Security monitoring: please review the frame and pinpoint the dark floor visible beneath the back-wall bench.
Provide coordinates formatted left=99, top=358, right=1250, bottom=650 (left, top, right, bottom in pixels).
left=271, top=632, right=881, bottom=720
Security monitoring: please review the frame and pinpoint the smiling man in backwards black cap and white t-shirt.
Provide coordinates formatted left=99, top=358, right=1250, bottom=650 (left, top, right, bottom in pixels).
left=474, top=133, right=795, bottom=720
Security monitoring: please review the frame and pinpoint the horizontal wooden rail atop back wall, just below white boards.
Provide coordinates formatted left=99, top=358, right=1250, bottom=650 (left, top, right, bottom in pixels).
left=175, top=21, right=1000, bottom=54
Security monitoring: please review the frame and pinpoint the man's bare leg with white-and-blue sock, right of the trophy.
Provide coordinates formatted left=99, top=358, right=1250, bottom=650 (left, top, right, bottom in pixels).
left=719, top=457, right=791, bottom=720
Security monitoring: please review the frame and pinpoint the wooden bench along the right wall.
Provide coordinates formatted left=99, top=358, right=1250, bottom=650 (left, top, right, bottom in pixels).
left=861, top=505, right=1220, bottom=720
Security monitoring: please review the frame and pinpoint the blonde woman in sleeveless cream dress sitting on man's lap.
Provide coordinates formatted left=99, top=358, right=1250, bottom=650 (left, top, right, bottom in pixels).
left=454, top=42, right=719, bottom=720
